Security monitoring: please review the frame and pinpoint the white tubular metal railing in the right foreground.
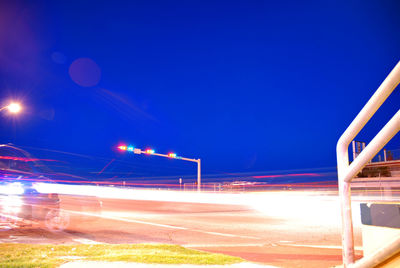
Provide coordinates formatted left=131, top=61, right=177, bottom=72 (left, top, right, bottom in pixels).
left=336, top=62, right=400, bottom=267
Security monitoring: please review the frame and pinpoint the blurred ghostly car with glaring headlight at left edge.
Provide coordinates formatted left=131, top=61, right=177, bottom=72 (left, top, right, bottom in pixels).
left=0, top=145, right=101, bottom=231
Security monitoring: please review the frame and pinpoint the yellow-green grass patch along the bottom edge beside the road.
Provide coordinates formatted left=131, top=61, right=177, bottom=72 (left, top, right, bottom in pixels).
left=0, top=243, right=243, bottom=268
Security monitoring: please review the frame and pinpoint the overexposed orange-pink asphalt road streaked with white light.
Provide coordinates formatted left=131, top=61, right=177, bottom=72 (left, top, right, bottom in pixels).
left=0, top=189, right=362, bottom=267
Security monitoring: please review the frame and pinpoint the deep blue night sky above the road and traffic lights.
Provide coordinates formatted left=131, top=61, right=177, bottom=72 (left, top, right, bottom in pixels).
left=0, top=0, right=400, bottom=181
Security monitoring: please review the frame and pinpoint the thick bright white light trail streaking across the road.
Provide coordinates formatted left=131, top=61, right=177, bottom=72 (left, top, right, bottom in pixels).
left=35, top=183, right=366, bottom=226
